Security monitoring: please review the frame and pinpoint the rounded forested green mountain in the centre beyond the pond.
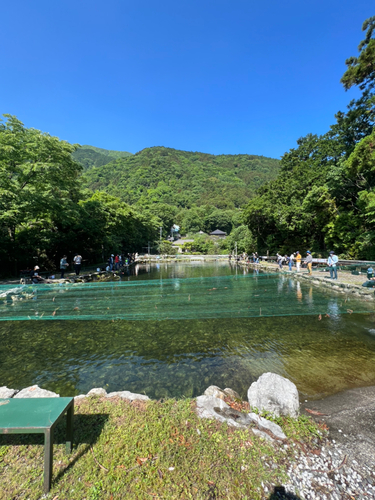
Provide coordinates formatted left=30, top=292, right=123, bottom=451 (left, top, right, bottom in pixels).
left=83, top=147, right=279, bottom=209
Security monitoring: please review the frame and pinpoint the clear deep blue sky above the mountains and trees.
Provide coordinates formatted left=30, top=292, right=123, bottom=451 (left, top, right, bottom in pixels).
left=0, top=0, right=375, bottom=158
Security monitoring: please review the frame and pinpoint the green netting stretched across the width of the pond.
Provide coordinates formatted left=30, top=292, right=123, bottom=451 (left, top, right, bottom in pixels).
left=0, top=273, right=374, bottom=321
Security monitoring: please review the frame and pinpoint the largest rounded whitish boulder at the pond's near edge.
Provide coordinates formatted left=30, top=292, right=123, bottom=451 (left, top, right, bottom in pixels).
left=247, top=373, right=299, bottom=418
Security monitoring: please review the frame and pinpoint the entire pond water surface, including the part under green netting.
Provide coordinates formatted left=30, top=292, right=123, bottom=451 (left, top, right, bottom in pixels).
left=0, top=262, right=375, bottom=399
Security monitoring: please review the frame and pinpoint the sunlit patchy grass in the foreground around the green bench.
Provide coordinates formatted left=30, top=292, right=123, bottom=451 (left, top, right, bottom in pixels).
left=0, top=397, right=323, bottom=500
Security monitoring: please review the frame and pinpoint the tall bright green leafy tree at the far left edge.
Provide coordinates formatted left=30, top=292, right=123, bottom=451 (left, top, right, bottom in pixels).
left=0, top=115, right=82, bottom=272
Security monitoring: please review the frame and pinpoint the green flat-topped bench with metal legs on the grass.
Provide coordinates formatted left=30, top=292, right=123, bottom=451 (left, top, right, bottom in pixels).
left=0, top=398, right=74, bottom=493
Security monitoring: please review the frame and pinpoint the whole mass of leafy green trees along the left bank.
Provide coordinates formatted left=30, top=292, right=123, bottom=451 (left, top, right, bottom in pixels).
left=0, top=115, right=159, bottom=274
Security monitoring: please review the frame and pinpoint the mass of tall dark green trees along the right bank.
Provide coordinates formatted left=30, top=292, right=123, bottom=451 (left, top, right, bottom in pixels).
left=245, top=16, right=375, bottom=259
